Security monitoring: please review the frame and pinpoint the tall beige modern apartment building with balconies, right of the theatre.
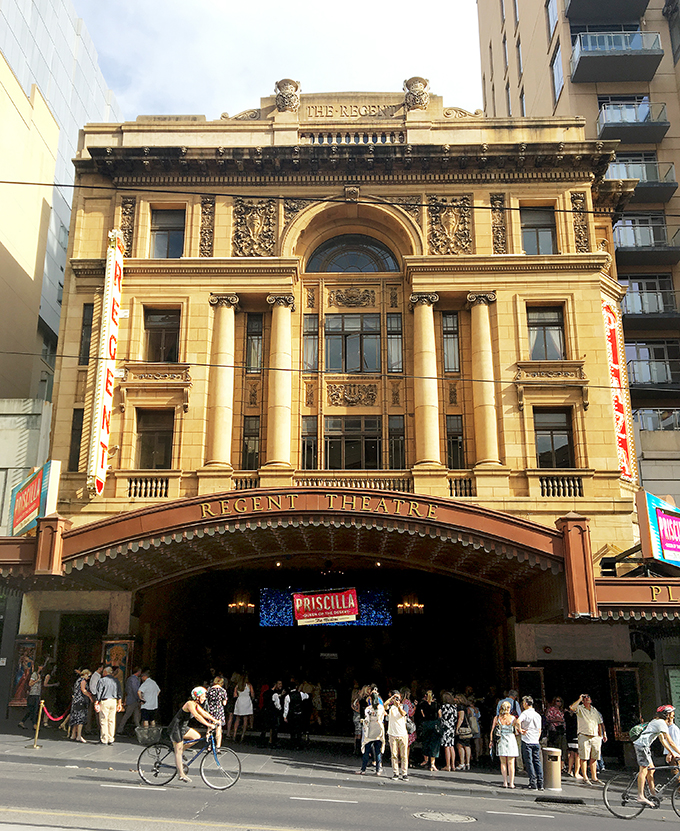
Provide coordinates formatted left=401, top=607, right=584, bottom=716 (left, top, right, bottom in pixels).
left=478, top=0, right=680, bottom=504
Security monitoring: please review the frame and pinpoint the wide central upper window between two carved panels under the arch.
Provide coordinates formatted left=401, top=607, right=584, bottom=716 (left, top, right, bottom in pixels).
left=325, top=314, right=380, bottom=373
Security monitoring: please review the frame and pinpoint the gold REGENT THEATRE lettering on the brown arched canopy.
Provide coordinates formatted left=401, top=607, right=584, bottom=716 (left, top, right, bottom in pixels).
left=200, top=493, right=437, bottom=519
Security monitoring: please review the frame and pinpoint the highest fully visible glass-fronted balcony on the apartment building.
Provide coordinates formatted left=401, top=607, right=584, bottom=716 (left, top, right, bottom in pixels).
left=571, top=32, right=663, bottom=84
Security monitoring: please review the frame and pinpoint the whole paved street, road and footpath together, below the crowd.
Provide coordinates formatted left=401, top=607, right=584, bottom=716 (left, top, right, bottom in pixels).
left=0, top=735, right=678, bottom=831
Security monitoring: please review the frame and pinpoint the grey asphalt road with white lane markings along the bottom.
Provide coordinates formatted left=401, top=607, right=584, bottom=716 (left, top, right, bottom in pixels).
left=0, top=762, right=680, bottom=831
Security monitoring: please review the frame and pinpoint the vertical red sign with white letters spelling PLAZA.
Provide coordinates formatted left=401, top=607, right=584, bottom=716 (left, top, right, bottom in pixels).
left=602, top=300, right=637, bottom=482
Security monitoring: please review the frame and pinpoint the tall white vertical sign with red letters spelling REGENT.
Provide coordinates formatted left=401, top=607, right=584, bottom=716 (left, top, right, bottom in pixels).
left=87, top=231, right=125, bottom=496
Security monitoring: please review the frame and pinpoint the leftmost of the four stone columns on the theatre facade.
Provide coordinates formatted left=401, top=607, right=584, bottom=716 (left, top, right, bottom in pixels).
left=206, top=294, right=238, bottom=470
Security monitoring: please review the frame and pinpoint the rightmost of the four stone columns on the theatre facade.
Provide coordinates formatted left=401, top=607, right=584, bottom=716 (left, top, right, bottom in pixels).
left=467, top=291, right=500, bottom=465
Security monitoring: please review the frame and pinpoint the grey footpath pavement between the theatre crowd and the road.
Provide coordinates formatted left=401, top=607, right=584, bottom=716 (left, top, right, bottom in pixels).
left=0, top=728, right=602, bottom=805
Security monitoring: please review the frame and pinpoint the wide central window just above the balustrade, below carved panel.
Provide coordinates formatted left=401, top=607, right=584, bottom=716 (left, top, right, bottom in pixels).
left=324, top=416, right=382, bottom=470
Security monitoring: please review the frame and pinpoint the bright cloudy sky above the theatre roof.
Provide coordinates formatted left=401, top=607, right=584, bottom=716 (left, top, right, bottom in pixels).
left=72, top=0, right=482, bottom=120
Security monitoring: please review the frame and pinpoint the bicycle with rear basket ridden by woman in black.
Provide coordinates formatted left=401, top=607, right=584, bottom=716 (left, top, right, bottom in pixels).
left=137, top=731, right=241, bottom=791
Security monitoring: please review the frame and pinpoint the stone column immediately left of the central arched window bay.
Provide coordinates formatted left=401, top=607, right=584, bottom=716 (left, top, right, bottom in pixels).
left=265, top=294, right=295, bottom=474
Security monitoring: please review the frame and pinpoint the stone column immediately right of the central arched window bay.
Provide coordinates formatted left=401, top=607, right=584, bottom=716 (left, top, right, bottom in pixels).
left=410, top=293, right=441, bottom=465
